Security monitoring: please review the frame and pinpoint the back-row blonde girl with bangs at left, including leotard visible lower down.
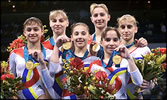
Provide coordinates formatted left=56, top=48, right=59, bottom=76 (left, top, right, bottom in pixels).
left=43, top=10, right=69, bottom=98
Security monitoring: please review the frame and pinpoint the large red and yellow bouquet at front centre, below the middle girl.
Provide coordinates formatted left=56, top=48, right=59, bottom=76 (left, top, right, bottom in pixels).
left=63, top=57, right=116, bottom=99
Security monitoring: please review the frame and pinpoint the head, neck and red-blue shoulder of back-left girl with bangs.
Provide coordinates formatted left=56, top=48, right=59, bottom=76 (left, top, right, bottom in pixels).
left=43, top=10, right=69, bottom=50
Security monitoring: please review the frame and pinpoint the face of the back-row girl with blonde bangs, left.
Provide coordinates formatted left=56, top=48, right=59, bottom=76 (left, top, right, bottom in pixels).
left=50, top=14, right=69, bottom=35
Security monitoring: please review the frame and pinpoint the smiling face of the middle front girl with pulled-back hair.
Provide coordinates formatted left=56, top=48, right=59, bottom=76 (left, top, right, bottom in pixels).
left=71, top=25, right=90, bottom=48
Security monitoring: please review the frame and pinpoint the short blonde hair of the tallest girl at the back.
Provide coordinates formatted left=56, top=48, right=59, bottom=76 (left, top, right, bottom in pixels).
left=90, top=3, right=109, bottom=15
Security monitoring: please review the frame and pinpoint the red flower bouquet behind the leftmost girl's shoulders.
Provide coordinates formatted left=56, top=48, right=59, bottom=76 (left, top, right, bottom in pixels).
left=7, top=25, right=48, bottom=52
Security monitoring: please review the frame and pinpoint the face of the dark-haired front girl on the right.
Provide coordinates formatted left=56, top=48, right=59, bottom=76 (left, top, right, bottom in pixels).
left=101, top=30, right=120, bottom=55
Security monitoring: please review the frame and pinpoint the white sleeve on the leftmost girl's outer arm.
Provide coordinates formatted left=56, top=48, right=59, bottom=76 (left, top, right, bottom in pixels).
left=9, top=53, right=17, bottom=77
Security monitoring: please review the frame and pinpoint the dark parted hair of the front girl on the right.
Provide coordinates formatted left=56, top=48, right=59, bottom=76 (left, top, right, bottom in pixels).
left=101, top=27, right=121, bottom=40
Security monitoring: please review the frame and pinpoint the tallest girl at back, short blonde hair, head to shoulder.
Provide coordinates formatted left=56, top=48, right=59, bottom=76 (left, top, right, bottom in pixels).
left=90, top=3, right=110, bottom=43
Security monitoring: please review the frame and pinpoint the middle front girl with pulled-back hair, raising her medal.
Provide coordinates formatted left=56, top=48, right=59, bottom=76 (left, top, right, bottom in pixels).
left=50, top=22, right=98, bottom=99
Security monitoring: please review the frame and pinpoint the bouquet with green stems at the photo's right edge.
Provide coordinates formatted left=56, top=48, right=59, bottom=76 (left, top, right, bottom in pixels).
left=134, top=48, right=166, bottom=81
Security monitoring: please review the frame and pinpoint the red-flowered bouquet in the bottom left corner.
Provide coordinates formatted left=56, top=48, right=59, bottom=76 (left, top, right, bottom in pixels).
left=0, top=61, right=23, bottom=99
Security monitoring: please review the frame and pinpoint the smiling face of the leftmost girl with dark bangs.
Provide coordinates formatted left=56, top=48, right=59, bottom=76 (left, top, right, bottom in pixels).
left=24, top=24, right=44, bottom=43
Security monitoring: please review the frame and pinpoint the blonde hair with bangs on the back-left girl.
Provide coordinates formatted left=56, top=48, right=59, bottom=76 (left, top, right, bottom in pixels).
left=49, top=10, right=68, bottom=21
